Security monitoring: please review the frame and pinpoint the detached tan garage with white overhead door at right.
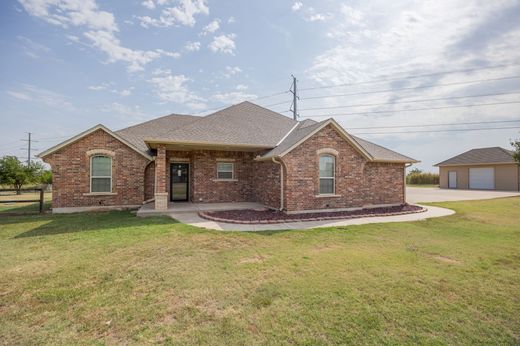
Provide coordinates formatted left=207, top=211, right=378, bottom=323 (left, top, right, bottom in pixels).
left=435, top=147, right=520, bottom=191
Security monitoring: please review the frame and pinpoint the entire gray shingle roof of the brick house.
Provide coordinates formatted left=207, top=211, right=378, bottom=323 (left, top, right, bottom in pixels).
left=116, top=101, right=416, bottom=162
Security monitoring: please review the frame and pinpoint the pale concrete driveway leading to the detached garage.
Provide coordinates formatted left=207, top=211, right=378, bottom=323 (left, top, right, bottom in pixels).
left=406, top=187, right=520, bottom=203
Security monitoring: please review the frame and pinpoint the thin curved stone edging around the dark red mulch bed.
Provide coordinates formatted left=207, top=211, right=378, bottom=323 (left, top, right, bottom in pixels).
left=198, top=204, right=428, bottom=225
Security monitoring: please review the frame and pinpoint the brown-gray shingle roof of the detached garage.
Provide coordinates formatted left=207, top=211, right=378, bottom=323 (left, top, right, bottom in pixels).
left=435, top=147, right=515, bottom=166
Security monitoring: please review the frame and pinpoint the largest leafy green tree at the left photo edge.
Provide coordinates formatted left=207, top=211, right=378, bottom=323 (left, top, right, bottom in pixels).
left=0, top=156, right=43, bottom=194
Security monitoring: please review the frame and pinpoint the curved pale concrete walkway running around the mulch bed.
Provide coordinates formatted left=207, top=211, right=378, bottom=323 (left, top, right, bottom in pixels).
left=168, top=206, right=455, bottom=231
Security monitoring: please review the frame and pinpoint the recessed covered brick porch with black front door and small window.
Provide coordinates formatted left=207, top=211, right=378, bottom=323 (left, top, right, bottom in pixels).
left=146, top=143, right=281, bottom=215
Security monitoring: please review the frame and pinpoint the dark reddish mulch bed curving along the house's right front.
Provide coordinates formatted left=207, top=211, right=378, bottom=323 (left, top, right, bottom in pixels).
left=199, top=204, right=427, bottom=224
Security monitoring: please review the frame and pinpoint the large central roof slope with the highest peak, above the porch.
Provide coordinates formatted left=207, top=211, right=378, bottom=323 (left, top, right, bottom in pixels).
left=149, top=101, right=297, bottom=147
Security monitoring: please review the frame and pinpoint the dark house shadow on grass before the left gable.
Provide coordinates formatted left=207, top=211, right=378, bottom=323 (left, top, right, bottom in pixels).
left=5, top=211, right=178, bottom=239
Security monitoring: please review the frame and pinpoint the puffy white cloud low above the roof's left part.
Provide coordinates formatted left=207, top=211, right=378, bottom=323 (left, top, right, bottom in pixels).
left=148, top=69, right=206, bottom=109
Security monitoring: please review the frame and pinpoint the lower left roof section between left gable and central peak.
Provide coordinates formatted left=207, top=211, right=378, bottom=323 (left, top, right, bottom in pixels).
left=115, top=114, right=202, bottom=152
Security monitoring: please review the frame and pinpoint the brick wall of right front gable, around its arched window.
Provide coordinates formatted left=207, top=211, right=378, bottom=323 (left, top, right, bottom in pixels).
left=283, top=125, right=404, bottom=211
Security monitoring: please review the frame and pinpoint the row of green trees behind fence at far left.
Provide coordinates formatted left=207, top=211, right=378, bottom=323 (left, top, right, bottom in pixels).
left=0, top=156, right=52, bottom=194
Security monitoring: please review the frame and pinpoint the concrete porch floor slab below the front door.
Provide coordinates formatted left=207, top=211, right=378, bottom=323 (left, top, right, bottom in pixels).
left=137, top=202, right=267, bottom=216
